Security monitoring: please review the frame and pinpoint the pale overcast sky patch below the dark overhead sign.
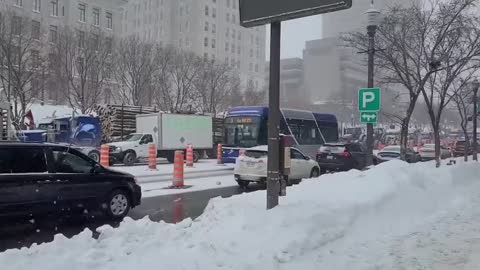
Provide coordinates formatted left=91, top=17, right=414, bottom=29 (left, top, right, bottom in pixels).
left=266, top=15, right=322, bottom=61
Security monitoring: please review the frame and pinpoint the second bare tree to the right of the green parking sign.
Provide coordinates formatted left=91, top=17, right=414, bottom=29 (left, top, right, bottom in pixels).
left=422, top=0, right=480, bottom=167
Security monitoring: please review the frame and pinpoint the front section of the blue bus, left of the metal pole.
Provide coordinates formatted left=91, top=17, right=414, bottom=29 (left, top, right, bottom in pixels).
left=222, top=106, right=268, bottom=163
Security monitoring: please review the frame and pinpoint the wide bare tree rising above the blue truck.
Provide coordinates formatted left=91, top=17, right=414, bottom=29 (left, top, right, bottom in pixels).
left=52, top=27, right=113, bottom=113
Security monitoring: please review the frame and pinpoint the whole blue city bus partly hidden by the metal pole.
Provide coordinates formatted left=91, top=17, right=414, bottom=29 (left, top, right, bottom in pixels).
left=222, top=106, right=338, bottom=163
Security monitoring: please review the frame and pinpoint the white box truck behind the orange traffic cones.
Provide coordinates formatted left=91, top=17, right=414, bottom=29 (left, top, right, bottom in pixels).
left=109, top=113, right=213, bottom=166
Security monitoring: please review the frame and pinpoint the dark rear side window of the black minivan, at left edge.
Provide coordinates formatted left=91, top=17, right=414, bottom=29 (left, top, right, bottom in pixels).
left=0, top=148, right=48, bottom=173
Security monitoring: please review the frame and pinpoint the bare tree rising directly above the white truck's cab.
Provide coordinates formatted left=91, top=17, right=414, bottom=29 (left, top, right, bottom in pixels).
left=115, top=36, right=155, bottom=105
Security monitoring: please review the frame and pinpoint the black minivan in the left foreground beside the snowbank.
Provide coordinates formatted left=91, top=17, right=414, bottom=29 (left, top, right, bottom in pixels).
left=0, top=142, right=141, bottom=220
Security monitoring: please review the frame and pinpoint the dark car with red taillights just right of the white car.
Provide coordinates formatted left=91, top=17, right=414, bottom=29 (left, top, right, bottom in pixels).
left=317, top=143, right=377, bottom=174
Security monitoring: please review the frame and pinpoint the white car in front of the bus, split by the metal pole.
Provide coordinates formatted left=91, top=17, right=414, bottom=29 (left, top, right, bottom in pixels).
left=234, top=145, right=320, bottom=187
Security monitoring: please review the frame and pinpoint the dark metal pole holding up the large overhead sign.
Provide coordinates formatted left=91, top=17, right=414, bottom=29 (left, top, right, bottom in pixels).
left=267, top=22, right=281, bottom=209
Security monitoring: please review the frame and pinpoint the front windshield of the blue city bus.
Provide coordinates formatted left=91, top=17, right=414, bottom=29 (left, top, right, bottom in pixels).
left=225, top=116, right=261, bottom=147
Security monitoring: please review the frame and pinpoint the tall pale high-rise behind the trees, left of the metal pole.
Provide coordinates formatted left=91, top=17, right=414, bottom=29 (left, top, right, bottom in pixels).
left=121, top=0, right=266, bottom=89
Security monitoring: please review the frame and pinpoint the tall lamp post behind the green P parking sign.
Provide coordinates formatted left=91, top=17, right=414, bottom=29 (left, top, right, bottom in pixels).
left=366, top=3, right=380, bottom=166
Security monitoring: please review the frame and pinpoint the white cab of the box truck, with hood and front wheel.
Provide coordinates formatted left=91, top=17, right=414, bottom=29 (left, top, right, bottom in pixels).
left=108, top=133, right=154, bottom=166
